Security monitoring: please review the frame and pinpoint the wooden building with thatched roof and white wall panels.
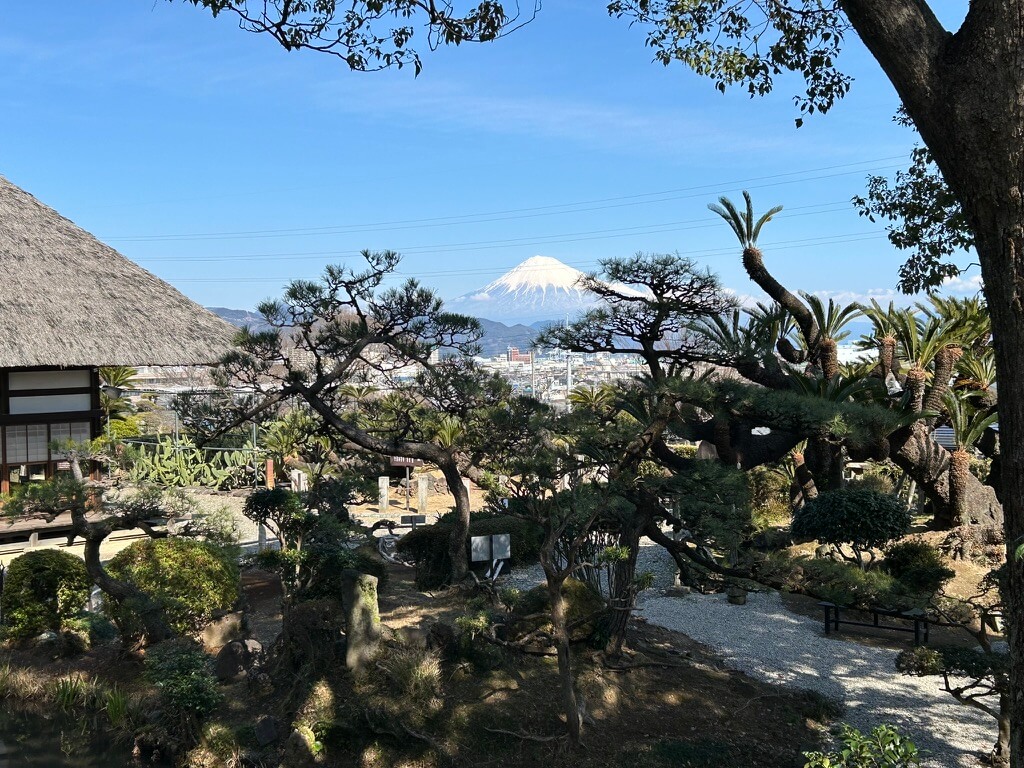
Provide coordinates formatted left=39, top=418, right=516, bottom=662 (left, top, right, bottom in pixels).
left=0, top=176, right=236, bottom=493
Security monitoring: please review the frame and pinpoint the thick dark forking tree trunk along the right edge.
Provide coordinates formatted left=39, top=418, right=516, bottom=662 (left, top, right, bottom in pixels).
left=842, top=0, right=1024, bottom=766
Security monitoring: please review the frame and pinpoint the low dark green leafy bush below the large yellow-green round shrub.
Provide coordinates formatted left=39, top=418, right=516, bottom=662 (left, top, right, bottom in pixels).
left=145, top=640, right=221, bottom=727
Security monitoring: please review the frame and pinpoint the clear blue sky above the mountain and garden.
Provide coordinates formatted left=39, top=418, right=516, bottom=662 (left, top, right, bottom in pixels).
left=0, top=0, right=976, bottom=308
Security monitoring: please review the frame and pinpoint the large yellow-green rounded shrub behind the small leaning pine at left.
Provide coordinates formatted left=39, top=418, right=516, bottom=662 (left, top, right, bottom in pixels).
left=106, top=537, right=239, bottom=637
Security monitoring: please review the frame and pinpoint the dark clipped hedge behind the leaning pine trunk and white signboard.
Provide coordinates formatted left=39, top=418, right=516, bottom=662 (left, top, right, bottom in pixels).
left=397, top=512, right=543, bottom=589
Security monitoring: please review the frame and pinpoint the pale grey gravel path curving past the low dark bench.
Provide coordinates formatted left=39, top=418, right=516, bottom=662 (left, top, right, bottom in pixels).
left=511, top=546, right=995, bottom=768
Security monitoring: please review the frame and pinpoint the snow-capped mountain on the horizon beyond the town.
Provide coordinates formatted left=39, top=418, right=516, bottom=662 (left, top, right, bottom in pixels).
left=445, top=256, right=597, bottom=323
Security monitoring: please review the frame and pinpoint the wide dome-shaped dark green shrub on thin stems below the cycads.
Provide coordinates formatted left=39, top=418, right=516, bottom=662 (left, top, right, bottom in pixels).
left=793, top=487, right=910, bottom=551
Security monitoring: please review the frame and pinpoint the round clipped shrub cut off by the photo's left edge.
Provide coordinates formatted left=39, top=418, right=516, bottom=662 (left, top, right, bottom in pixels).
left=0, top=549, right=92, bottom=639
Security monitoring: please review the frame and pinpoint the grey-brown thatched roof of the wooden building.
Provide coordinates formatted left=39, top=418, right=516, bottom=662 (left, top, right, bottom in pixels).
left=0, top=176, right=236, bottom=368
